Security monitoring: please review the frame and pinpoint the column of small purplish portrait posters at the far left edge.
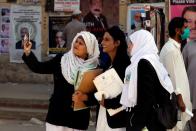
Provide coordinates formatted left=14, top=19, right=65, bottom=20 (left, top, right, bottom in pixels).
left=0, top=6, right=10, bottom=54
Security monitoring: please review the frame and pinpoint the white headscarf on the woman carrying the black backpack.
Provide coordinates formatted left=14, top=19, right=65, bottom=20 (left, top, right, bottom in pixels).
left=120, top=29, right=174, bottom=107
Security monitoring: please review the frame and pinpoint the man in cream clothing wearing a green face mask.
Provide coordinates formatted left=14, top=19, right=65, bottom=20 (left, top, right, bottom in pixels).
left=160, top=17, right=192, bottom=131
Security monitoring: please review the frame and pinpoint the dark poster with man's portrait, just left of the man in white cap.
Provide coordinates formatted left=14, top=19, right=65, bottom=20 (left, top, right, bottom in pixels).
left=49, top=16, right=71, bottom=55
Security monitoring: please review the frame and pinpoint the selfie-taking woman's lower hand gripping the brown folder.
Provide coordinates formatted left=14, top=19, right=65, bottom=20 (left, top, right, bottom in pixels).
left=72, top=90, right=88, bottom=103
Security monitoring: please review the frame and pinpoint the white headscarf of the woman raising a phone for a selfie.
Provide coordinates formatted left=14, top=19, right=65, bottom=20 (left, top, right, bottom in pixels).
left=61, top=31, right=100, bottom=85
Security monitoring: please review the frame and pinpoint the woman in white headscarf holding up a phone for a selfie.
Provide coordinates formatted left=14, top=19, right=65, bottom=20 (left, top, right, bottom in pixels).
left=23, top=31, right=99, bottom=131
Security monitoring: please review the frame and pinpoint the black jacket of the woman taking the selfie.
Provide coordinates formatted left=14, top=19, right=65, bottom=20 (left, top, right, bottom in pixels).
left=22, top=52, right=90, bottom=130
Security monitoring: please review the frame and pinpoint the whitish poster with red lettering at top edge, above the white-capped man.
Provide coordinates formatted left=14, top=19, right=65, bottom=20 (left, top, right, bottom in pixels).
left=54, top=0, right=80, bottom=12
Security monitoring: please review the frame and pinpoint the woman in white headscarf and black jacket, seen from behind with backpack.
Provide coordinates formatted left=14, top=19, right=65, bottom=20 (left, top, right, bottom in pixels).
left=120, top=29, right=174, bottom=131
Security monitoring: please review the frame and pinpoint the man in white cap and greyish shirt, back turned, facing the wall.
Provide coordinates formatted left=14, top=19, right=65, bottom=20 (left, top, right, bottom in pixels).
left=63, top=10, right=86, bottom=51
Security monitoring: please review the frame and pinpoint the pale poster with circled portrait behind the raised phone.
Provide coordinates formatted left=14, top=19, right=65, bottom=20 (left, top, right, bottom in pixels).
left=10, top=5, right=41, bottom=63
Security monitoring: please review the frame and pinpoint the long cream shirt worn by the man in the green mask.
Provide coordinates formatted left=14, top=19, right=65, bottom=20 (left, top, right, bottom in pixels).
left=160, top=38, right=192, bottom=128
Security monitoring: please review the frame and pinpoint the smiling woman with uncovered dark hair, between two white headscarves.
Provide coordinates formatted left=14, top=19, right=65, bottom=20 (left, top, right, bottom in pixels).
left=95, top=26, right=130, bottom=131
